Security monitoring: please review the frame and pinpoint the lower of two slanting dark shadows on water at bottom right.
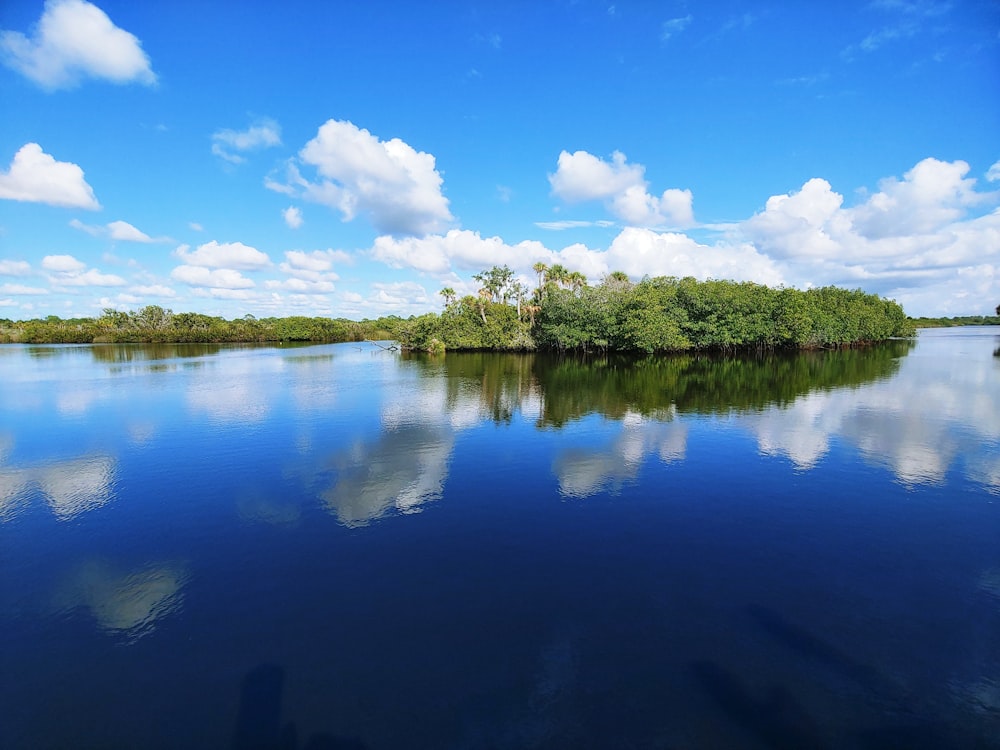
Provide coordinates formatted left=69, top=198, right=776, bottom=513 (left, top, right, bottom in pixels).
left=691, top=661, right=827, bottom=750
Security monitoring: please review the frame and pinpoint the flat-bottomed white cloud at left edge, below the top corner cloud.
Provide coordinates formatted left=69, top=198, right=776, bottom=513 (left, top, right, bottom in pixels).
left=0, top=143, right=101, bottom=210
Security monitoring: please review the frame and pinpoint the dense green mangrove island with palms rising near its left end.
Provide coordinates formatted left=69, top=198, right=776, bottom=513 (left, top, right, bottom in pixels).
left=400, top=263, right=915, bottom=353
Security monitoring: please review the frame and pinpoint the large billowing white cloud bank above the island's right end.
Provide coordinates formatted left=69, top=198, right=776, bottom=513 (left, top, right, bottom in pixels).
left=736, top=159, right=1000, bottom=308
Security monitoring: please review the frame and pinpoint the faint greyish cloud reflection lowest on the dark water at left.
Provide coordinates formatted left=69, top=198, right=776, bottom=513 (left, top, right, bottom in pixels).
left=55, top=559, right=188, bottom=642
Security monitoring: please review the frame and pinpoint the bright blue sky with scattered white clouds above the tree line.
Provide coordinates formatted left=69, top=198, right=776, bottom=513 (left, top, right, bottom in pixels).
left=0, top=0, right=1000, bottom=319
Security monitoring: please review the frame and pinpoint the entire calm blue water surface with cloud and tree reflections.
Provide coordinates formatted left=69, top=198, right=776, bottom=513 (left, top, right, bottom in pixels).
left=0, top=328, right=1000, bottom=750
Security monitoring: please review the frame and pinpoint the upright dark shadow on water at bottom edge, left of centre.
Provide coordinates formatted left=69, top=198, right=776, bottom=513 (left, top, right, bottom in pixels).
left=230, top=664, right=368, bottom=750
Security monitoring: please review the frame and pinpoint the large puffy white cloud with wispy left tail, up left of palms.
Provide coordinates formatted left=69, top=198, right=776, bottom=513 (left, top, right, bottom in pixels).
left=265, top=120, right=453, bottom=236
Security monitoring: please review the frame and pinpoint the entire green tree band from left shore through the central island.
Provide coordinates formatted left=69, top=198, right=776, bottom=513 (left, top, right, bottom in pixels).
left=0, top=263, right=914, bottom=353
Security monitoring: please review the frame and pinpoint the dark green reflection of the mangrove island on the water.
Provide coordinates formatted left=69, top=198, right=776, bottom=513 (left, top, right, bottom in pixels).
left=406, top=340, right=914, bottom=428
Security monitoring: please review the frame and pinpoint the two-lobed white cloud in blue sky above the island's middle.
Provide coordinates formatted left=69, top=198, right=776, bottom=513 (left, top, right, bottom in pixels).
left=549, top=151, right=694, bottom=227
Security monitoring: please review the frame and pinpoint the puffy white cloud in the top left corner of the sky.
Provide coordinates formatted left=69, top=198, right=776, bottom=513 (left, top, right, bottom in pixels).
left=0, top=0, right=156, bottom=90
